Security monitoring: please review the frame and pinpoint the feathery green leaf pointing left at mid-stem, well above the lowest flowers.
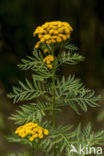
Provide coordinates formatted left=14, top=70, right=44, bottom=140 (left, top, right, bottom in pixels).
left=8, top=77, right=47, bottom=103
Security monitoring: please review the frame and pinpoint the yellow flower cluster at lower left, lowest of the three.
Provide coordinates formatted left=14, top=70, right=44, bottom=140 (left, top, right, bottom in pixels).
left=15, top=122, right=49, bottom=141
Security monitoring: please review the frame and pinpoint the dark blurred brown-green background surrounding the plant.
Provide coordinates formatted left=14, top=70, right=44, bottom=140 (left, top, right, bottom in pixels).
left=0, top=0, right=104, bottom=156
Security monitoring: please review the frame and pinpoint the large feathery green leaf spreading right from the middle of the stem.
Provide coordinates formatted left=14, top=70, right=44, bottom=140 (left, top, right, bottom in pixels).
left=56, top=76, right=101, bottom=114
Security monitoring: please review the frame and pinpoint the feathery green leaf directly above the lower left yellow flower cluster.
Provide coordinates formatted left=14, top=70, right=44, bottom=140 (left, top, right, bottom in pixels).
left=9, top=101, right=59, bottom=125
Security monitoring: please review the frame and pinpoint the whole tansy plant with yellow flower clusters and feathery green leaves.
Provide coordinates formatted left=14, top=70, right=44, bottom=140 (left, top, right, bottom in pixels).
left=8, top=21, right=104, bottom=156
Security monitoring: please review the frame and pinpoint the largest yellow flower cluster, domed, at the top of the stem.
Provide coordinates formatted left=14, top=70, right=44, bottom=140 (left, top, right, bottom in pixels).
left=33, top=21, right=73, bottom=48
